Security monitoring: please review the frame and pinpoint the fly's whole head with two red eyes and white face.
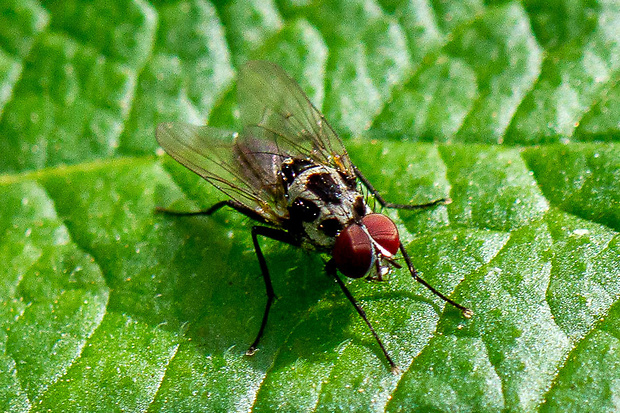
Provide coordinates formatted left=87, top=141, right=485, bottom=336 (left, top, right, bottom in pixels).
left=333, top=213, right=400, bottom=280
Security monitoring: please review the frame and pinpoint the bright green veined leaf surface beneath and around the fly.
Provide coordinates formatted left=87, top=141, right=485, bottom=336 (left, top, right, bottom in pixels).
left=0, top=0, right=620, bottom=412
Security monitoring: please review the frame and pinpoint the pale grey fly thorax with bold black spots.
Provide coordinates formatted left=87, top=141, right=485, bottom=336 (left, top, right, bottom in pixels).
left=281, top=159, right=371, bottom=250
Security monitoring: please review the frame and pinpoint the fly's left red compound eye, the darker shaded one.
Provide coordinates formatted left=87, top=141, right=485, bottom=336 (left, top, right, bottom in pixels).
left=332, top=224, right=373, bottom=278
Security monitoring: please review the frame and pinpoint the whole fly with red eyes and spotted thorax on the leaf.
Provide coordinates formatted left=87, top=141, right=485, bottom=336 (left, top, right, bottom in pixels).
left=157, top=61, right=473, bottom=371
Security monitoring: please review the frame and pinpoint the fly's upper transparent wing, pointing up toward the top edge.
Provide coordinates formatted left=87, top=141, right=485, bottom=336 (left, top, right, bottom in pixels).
left=237, top=61, right=354, bottom=176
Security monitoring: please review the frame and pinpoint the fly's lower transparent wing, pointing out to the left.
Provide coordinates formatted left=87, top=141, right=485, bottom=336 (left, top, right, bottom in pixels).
left=156, top=123, right=287, bottom=223
